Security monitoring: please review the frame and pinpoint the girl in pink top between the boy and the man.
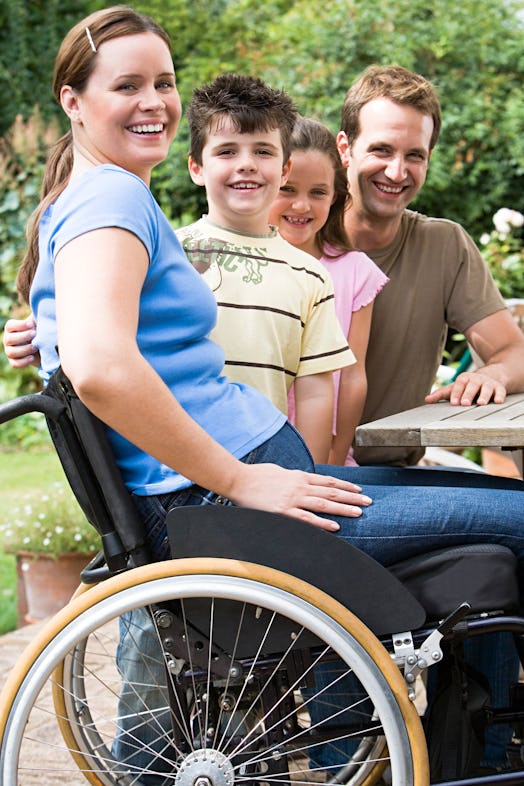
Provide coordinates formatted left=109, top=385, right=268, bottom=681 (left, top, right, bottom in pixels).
left=270, top=113, right=388, bottom=465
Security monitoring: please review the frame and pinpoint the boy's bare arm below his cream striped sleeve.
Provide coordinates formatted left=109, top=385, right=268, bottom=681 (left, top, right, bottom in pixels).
left=294, top=371, right=334, bottom=464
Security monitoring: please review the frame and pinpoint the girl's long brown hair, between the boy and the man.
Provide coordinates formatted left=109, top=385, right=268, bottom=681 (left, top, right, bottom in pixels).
left=291, top=117, right=353, bottom=257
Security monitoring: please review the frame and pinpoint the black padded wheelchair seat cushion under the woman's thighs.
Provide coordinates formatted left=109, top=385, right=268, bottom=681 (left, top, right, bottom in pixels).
left=389, top=543, right=519, bottom=620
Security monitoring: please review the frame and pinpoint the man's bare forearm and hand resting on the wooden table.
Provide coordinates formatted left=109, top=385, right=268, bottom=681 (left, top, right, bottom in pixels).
left=426, top=309, right=524, bottom=406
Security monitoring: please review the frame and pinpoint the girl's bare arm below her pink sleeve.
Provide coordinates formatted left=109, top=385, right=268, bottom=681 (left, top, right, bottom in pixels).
left=329, top=303, right=373, bottom=466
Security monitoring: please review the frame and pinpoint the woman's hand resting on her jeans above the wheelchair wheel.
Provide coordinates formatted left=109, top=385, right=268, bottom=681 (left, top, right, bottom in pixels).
left=228, top=464, right=372, bottom=532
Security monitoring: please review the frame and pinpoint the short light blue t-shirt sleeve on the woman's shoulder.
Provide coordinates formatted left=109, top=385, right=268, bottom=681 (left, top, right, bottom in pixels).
left=49, top=165, right=158, bottom=260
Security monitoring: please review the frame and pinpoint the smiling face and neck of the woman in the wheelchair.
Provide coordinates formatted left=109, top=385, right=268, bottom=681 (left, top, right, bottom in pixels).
left=61, top=32, right=182, bottom=182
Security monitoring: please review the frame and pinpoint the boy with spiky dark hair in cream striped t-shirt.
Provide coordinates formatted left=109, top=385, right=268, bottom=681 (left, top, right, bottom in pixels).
left=177, top=74, right=355, bottom=463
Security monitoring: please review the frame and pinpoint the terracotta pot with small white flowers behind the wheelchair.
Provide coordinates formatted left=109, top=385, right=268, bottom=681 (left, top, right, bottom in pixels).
left=0, top=482, right=100, bottom=622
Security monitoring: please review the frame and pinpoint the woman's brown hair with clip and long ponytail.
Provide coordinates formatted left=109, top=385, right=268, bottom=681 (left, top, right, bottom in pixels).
left=16, top=5, right=171, bottom=302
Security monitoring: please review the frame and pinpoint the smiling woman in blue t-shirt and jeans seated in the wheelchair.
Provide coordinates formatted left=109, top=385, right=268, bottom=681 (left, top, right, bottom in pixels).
left=3, top=6, right=524, bottom=786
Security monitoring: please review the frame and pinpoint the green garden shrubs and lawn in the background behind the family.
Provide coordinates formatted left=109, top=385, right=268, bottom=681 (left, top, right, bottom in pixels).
left=0, top=0, right=524, bottom=631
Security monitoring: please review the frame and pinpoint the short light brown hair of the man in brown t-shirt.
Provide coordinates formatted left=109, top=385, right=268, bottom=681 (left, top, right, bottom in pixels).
left=340, top=65, right=442, bottom=150
